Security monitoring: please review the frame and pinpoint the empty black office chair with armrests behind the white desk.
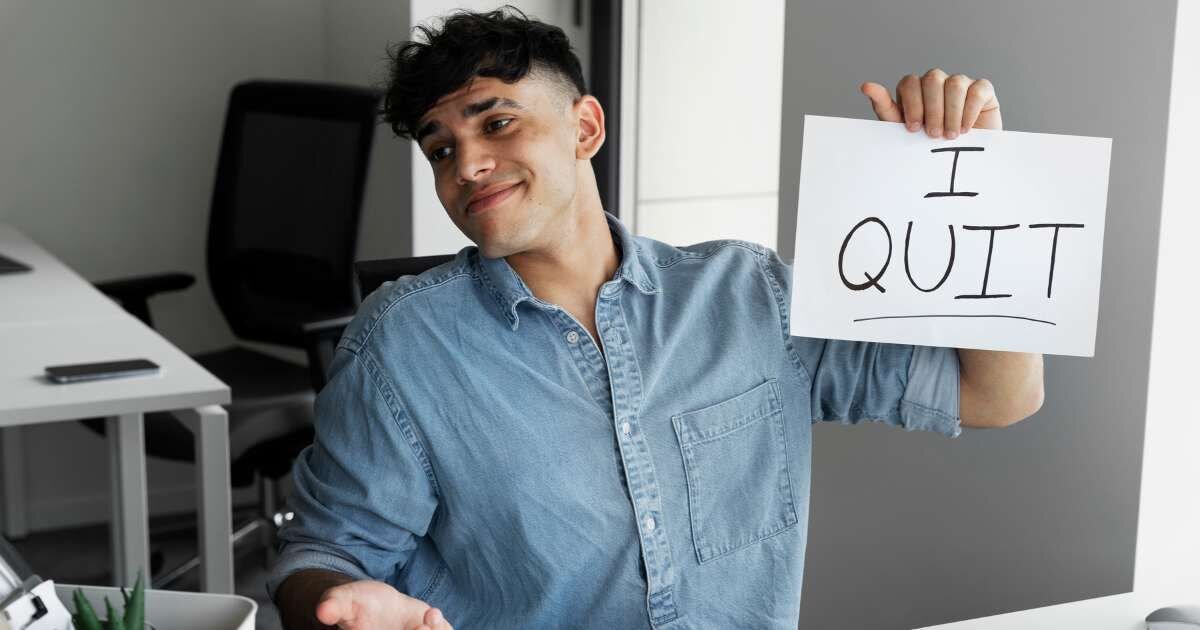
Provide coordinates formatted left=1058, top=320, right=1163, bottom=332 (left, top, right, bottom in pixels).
left=85, top=80, right=378, bottom=586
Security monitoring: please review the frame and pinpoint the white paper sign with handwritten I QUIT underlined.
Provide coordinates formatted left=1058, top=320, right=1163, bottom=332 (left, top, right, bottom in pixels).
left=791, top=115, right=1112, bottom=356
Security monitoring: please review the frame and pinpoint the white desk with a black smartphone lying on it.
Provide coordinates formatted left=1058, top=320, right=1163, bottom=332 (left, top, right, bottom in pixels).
left=0, top=224, right=233, bottom=593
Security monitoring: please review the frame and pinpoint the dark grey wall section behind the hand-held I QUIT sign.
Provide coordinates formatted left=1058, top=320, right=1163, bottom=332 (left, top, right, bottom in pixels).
left=779, top=0, right=1175, bottom=630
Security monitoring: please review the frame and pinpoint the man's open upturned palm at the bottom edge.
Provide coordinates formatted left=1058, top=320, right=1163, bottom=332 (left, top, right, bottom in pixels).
left=316, top=580, right=454, bottom=630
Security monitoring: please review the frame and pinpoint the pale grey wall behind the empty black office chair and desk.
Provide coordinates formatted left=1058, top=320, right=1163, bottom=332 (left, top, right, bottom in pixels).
left=0, top=0, right=410, bottom=529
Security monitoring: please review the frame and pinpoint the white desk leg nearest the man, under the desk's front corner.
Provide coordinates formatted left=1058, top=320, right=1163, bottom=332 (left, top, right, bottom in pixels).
left=174, top=404, right=233, bottom=593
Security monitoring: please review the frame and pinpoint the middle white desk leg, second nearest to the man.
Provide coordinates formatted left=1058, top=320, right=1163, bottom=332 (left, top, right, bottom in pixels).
left=107, top=414, right=150, bottom=587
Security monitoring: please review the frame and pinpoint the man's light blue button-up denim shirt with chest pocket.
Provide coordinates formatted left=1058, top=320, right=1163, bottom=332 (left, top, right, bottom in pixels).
left=268, top=210, right=960, bottom=629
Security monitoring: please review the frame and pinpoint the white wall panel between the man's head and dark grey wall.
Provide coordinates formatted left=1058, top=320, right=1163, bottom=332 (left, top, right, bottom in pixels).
left=632, top=0, right=784, bottom=247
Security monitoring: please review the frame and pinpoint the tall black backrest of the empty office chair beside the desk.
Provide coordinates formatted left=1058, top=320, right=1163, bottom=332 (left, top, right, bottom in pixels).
left=208, top=80, right=379, bottom=347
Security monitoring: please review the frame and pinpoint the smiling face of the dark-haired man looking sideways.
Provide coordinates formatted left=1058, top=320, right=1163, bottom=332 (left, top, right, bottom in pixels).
left=416, top=73, right=578, bottom=258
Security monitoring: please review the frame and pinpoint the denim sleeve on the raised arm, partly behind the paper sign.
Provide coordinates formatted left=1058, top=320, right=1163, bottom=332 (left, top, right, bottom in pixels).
left=763, top=250, right=962, bottom=438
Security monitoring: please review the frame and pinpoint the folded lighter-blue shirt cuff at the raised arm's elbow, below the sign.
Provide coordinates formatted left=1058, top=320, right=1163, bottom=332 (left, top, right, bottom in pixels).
left=900, top=346, right=962, bottom=438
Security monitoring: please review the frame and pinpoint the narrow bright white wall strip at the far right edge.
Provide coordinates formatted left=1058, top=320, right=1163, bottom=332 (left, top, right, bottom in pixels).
left=1134, top=1, right=1200, bottom=604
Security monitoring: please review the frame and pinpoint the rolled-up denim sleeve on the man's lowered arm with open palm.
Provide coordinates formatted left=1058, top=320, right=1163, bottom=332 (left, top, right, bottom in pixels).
left=266, top=348, right=437, bottom=599
